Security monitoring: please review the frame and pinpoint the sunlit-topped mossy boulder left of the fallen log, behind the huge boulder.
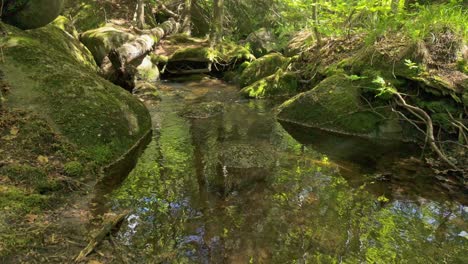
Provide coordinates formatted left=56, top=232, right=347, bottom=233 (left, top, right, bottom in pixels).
left=80, top=24, right=135, bottom=65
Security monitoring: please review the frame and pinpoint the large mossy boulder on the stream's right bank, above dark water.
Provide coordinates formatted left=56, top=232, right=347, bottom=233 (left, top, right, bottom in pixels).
left=278, top=75, right=402, bottom=138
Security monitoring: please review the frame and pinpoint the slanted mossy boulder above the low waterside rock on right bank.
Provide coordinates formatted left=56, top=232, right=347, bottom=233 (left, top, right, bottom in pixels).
left=239, top=53, right=290, bottom=87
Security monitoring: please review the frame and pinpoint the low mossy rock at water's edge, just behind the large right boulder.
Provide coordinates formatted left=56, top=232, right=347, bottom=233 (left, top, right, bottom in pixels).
left=241, top=69, right=299, bottom=98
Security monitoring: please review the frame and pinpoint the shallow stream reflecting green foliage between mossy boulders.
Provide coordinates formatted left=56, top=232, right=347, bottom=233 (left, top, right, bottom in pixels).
left=90, top=79, right=468, bottom=263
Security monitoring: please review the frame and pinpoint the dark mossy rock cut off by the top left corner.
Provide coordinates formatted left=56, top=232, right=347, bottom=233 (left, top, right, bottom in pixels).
left=2, top=0, right=64, bottom=29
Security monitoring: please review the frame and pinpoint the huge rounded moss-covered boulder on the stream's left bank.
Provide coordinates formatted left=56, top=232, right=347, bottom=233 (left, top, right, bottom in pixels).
left=0, top=22, right=151, bottom=164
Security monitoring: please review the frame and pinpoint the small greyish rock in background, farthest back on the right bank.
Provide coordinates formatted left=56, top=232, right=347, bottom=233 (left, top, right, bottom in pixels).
left=245, top=28, right=278, bottom=57
